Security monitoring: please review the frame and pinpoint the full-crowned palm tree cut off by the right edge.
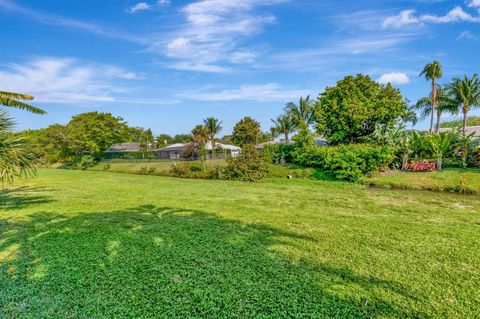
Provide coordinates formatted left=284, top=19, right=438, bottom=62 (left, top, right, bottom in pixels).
left=449, top=73, right=480, bottom=136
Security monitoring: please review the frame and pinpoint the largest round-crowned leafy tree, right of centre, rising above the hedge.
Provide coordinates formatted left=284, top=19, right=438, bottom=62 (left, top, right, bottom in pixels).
left=315, top=74, right=411, bottom=144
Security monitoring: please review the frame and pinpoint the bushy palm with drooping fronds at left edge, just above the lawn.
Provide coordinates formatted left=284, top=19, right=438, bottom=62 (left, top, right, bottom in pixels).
left=0, top=110, right=35, bottom=186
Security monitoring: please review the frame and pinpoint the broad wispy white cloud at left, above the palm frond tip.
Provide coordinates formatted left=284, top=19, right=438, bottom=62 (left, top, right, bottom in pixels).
left=0, top=57, right=180, bottom=104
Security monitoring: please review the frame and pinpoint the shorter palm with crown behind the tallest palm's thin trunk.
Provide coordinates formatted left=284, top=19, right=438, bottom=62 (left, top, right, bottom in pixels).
left=415, top=85, right=458, bottom=132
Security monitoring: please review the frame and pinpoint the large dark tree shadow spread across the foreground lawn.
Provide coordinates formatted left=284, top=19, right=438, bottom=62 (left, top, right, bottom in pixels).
left=0, top=206, right=422, bottom=318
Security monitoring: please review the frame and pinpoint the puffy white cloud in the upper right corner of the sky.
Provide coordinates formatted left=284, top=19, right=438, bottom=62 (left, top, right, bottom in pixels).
left=382, top=6, right=480, bottom=29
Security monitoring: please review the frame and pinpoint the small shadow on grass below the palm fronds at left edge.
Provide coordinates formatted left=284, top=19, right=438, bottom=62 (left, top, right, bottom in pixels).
left=0, top=186, right=53, bottom=210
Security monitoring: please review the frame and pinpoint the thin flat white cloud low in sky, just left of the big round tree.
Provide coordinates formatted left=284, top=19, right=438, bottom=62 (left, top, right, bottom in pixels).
left=180, top=83, right=310, bottom=102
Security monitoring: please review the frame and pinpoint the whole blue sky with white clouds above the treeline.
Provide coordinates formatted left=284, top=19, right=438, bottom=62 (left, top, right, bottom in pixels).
left=0, top=0, right=480, bottom=134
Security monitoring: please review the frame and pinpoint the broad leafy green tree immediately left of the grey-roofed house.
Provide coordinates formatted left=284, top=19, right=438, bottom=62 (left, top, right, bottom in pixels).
left=66, top=112, right=126, bottom=158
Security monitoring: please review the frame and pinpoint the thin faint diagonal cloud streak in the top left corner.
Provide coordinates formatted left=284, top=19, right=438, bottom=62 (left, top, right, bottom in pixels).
left=0, top=0, right=148, bottom=44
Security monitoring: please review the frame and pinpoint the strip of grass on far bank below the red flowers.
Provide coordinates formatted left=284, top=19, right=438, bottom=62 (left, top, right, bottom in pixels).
left=363, top=168, right=480, bottom=194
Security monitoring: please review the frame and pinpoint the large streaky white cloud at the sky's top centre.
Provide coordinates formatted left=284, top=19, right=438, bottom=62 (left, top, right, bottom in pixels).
left=158, top=0, right=285, bottom=72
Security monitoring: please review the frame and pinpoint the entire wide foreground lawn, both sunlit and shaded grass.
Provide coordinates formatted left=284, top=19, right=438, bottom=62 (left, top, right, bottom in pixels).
left=0, top=169, right=480, bottom=318
